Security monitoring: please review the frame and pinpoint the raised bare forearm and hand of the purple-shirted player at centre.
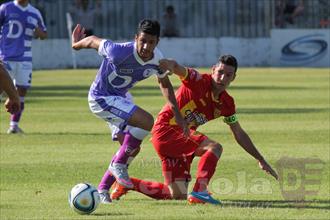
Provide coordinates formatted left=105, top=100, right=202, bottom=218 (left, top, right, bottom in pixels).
left=71, top=24, right=102, bottom=50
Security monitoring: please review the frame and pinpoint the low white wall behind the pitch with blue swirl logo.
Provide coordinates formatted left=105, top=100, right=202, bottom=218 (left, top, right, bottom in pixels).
left=32, top=29, right=330, bottom=69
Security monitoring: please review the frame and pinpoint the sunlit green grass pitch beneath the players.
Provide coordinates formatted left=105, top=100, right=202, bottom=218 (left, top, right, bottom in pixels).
left=0, top=68, right=330, bottom=220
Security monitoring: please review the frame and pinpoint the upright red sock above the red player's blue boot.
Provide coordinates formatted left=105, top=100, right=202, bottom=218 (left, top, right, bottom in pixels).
left=193, top=151, right=219, bottom=192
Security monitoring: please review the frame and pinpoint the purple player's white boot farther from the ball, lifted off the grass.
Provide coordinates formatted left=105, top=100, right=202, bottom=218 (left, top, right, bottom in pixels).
left=109, top=163, right=134, bottom=189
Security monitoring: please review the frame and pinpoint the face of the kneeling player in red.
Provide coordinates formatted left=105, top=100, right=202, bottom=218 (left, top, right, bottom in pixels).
left=212, top=63, right=235, bottom=90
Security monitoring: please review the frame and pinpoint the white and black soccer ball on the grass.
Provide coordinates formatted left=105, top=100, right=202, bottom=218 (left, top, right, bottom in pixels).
left=69, top=183, right=100, bottom=214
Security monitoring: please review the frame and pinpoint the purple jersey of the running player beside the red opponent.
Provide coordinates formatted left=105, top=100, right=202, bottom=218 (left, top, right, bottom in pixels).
left=89, top=40, right=166, bottom=98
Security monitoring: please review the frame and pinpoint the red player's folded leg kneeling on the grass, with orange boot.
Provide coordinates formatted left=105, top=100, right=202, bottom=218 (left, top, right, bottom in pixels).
left=111, top=122, right=202, bottom=199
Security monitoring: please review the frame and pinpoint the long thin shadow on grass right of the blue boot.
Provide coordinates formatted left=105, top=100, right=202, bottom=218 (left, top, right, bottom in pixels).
left=222, top=200, right=330, bottom=210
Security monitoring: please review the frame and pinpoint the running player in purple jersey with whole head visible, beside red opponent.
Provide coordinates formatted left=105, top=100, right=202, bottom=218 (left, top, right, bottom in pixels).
left=72, top=19, right=188, bottom=203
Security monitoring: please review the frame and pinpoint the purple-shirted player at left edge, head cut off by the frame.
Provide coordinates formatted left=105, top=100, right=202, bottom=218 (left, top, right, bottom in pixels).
left=0, top=0, right=47, bottom=134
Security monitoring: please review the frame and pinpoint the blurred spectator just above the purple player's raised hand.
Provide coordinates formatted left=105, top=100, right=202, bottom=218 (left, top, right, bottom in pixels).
left=71, top=0, right=100, bottom=37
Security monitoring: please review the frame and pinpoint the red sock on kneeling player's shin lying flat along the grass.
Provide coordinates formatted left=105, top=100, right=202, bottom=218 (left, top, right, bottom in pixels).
left=131, top=177, right=172, bottom=199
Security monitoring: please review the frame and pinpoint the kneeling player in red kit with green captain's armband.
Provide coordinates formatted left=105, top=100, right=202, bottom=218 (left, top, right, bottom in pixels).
left=111, top=55, right=278, bottom=204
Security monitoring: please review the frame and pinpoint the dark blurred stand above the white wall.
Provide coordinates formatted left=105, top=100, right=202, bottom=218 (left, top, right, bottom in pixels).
left=9, top=0, right=330, bottom=40
